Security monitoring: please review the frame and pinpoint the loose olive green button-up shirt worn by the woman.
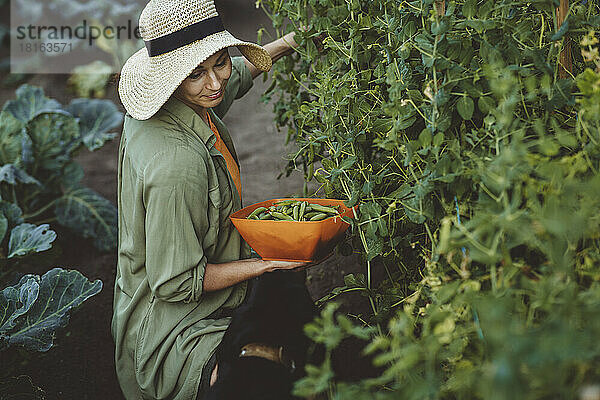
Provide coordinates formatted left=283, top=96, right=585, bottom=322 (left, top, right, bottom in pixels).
left=111, top=57, right=253, bottom=400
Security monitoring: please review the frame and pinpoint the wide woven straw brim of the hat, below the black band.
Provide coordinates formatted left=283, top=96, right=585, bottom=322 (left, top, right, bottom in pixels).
left=118, top=30, right=272, bottom=120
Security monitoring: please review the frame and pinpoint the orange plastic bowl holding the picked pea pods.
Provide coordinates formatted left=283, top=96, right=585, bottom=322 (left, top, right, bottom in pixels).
left=229, top=198, right=354, bottom=262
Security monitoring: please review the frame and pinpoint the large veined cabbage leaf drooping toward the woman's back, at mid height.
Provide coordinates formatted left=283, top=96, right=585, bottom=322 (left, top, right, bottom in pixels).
left=55, top=186, right=117, bottom=251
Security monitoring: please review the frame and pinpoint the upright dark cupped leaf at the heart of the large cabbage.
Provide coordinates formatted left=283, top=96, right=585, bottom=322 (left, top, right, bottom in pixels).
left=27, top=111, right=81, bottom=170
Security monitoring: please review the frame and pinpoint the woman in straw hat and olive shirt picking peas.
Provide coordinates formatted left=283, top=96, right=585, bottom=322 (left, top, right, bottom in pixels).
left=112, top=0, right=318, bottom=400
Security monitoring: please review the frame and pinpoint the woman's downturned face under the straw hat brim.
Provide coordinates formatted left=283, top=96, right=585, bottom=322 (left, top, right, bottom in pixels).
left=173, top=49, right=231, bottom=111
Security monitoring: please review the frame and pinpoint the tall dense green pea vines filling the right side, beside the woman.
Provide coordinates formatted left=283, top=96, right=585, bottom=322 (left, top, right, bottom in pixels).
left=257, top=0, right=600, bottom=399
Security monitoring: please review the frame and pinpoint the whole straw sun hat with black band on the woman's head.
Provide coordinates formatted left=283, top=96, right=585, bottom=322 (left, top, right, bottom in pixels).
left=119, top=0, right=272, bottom=120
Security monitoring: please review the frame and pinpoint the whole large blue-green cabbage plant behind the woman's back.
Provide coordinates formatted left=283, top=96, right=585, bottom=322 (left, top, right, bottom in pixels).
left=0, top=85, right=123, bottom=250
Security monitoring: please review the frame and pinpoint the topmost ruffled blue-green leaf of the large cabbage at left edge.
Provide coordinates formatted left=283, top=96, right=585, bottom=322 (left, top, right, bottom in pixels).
left=2, top=84, right=61, bottom=123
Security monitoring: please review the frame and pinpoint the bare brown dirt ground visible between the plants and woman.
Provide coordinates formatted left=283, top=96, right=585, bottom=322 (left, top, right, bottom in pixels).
left=0, top=0, right=380, bottom=400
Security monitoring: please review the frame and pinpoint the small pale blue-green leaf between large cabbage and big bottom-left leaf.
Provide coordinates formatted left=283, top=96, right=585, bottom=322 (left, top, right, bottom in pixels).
left=8, top=223, right=56, bottom=258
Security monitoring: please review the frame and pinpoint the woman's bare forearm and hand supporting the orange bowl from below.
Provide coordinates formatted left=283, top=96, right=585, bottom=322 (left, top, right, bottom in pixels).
left=202, top=258, right=311, bottom=292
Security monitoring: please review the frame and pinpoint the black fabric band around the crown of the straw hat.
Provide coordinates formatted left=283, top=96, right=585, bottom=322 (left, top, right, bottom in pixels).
left=144, top=16, right=225, bottom=57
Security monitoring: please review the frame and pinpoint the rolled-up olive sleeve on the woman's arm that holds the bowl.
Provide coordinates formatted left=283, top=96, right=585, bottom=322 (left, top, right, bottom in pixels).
left=143, top=148, right=209, bottom=302
